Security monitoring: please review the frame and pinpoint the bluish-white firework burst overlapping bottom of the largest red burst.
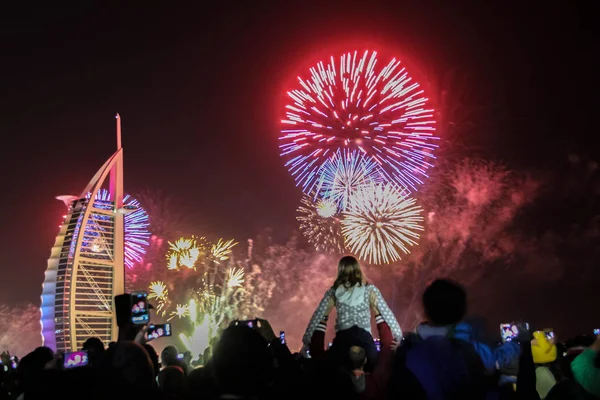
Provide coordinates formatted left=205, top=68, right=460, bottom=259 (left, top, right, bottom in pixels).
left=316, top=149, right=384, bottom=212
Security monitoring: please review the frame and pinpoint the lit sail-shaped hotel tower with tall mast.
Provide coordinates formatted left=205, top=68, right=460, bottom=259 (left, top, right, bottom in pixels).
left=41, top=114, right=126, bottom=351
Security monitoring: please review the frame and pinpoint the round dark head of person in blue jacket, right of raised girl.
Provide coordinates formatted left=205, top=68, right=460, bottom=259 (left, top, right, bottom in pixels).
left=423, top=279, right=467, bottom=326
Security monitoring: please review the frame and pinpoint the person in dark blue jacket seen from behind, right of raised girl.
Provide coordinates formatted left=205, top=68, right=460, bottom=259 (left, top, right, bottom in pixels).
left=392, top=280, right=486, bottom=399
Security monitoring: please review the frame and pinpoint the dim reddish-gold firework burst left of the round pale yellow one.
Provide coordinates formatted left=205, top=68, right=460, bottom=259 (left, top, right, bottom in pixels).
left=296, top=196, right=344, bottom=253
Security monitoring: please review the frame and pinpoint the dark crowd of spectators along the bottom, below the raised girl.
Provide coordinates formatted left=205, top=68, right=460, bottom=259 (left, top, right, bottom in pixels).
left=0, top=280, right=600, bottom=400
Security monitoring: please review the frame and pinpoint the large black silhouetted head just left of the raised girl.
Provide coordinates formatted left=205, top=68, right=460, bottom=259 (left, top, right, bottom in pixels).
left=211, top=326, right=274, bottom=396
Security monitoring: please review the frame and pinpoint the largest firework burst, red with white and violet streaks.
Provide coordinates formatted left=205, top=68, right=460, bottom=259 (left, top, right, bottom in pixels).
left=280, top=51, right=437, bottom=194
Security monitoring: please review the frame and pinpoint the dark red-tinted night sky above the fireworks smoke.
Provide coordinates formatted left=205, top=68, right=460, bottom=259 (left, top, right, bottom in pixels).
left=0, top=0, right=600, bottom=322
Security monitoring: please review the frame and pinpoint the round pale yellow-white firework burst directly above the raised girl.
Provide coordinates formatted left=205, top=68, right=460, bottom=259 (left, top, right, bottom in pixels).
left=342, top=184, right=423, bottom=264
